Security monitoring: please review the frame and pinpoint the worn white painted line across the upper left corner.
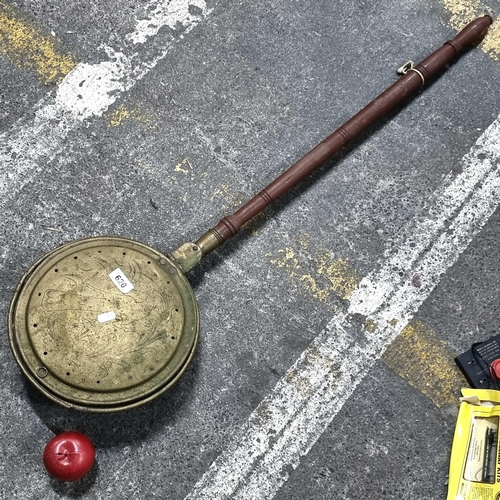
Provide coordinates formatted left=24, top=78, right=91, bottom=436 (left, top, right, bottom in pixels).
left=0, top=0, right=211, bottom=203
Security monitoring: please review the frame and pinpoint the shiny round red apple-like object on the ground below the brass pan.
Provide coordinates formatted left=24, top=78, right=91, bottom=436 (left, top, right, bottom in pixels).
left=43, top=431, right=95, bottom=481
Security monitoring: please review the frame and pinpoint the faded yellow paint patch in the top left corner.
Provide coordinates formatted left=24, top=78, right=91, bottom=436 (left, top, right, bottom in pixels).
left=0, top=0, right=77, bottom=85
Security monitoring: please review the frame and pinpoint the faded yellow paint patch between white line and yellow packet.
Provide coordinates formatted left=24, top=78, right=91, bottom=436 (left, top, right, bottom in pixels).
left=382, top=320, right=468, bottom=407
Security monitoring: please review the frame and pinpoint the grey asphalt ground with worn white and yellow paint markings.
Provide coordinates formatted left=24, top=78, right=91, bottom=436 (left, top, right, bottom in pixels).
left=0, top=0, right=500, bottom=500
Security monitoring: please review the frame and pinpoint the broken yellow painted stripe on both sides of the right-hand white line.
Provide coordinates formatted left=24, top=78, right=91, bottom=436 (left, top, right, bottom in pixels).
left=268, top=242, right=468, bottom=407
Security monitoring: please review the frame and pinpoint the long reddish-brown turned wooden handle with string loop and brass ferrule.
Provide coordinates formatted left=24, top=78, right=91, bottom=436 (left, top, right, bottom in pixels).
left=196, top=16, right=492, bottom=255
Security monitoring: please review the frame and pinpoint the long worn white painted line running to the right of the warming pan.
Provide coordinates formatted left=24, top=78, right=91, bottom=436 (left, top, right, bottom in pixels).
left=186, top=117, right=500, bottom=500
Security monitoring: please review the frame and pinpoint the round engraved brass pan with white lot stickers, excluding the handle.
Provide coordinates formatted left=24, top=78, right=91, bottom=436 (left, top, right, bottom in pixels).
left=9, top=237, right=199, bottom=412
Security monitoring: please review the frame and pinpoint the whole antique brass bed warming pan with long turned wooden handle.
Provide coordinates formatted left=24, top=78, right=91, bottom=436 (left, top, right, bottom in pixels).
left=9, top=16, right=492, bottom=412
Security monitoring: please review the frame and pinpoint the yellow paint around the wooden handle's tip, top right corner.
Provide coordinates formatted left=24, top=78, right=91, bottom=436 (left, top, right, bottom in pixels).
left=442, top=0, right=500, bottom=61
